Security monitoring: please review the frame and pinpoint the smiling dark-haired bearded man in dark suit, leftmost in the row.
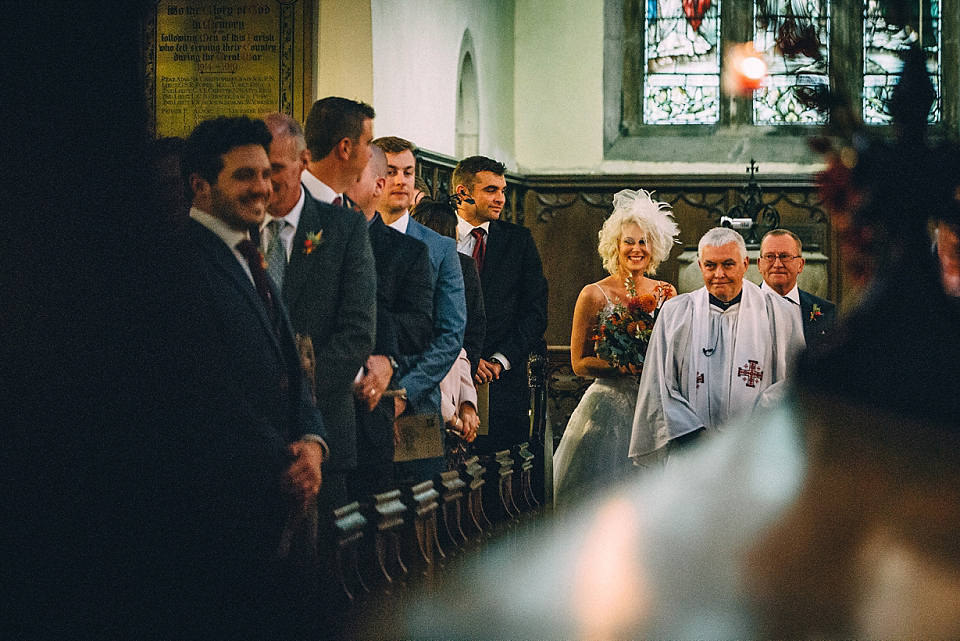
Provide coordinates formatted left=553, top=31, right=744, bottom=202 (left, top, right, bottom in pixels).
left=182, top=117, right=327, bottom=636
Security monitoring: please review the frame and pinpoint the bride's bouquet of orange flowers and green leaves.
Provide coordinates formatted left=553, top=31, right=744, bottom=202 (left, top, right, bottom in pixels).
left=593, top=279, right=666, bottom=369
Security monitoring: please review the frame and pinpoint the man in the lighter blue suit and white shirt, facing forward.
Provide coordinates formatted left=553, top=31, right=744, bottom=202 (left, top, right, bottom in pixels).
left=373, top=137, right=467, bottom=480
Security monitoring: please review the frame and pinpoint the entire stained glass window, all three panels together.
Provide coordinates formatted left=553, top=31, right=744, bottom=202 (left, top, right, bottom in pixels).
left=633, top=0, right=944, bottom=125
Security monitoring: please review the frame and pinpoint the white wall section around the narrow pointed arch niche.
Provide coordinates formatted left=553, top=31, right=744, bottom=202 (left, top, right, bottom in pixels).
left=370, top=0, right=516, bottom=168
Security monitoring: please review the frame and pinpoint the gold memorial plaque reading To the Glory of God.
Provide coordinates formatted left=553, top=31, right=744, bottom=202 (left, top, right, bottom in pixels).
left=145, top=0, right=313, bottom=136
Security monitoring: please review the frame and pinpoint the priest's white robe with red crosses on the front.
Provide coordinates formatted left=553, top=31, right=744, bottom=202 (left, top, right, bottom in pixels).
left=630, top=281, right=804, bottom=459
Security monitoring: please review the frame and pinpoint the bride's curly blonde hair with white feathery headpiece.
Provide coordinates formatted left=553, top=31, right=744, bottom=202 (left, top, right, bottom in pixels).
left=597, top=189, right=680, bottom=276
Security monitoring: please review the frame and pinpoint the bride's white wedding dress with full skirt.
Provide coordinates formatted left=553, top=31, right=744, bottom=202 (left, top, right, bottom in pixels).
left=553, top=285, right=639, bottom=506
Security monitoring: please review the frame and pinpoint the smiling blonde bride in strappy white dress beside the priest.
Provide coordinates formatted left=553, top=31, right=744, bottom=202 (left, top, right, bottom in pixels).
left=553, top=189, right=679, bottom=505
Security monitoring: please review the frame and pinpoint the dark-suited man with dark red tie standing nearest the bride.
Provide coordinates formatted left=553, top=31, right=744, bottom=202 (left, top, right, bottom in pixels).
left=452, top=156, right=547, bottom=452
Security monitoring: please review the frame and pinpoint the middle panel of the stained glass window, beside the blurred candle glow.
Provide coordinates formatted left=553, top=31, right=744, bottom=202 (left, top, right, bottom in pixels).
left=753, top=0, right=830, bottom=125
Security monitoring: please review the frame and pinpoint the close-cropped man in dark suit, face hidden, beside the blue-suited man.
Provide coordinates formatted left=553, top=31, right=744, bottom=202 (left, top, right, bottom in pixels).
left=346, top=145, right=433, bottom=500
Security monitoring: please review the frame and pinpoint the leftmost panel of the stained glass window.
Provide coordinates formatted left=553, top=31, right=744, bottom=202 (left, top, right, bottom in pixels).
left=643, top=0, right=720, bottom=125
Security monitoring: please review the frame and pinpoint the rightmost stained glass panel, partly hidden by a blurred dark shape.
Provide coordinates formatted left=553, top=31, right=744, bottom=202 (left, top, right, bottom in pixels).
left=863, top=0, right=941, bottom=125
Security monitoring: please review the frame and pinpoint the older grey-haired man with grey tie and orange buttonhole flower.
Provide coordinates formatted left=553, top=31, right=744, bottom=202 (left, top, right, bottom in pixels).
left=261, top=113, right=376, bottom=511
